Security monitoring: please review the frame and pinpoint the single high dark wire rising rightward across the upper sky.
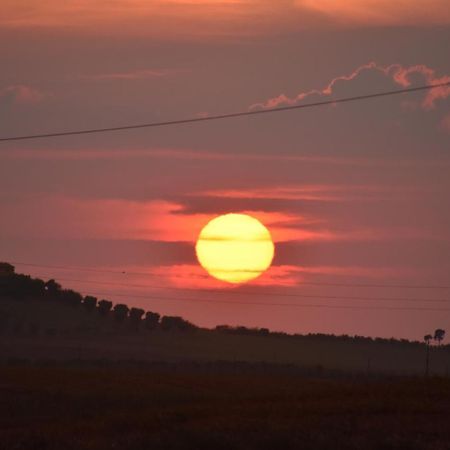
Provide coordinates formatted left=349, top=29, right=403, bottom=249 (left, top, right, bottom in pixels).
left=0, top=82, right=450, bottom=142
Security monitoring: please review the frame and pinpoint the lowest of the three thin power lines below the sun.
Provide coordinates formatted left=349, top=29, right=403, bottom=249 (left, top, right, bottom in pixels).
left=85, top=292, right=450, bottom=312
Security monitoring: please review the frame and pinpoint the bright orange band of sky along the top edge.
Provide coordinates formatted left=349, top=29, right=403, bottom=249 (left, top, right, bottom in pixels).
left=0, top=0, right=450, bottom=37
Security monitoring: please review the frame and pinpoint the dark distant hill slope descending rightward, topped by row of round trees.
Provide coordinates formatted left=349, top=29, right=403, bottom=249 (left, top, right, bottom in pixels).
left=0, top=263, right=450, bottom=374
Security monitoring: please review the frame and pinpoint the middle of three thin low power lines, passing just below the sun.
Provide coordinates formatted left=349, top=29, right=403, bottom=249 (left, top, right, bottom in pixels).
left=51, top=278, right=450, bottom=303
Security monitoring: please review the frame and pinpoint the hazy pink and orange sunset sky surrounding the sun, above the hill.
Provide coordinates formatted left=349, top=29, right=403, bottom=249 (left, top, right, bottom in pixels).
left=0, top=0, right=450, bottom=339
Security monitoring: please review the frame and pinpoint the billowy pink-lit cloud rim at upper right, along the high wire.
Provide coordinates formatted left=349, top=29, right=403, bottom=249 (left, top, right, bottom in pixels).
left=250, top=62, right=450, bottom=110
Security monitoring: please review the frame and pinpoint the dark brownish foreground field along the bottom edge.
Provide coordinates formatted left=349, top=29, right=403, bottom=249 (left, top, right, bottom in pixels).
left=0, top=365, right=450, bottom=450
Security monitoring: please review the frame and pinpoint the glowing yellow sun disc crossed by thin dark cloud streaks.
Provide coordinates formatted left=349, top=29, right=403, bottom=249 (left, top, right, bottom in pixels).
left=195, top=214, right=275, bottom=284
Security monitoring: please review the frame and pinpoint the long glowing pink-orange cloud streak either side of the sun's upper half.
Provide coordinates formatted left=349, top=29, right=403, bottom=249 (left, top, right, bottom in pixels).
left=0, top=195, right=443, bottom=244
